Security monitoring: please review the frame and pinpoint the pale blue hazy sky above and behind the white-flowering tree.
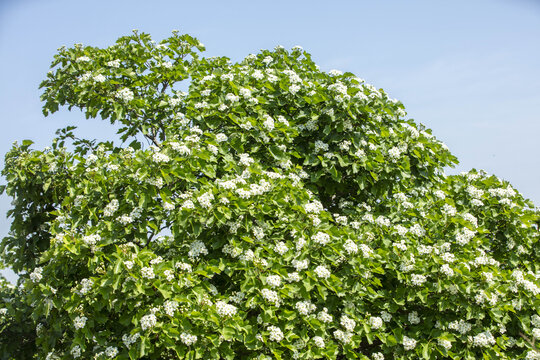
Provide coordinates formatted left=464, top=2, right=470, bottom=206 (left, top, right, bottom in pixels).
left=0, top=0, right=540, bottom=280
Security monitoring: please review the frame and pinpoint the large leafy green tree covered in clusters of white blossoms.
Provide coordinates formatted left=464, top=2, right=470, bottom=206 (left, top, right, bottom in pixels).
left=0, top=32, right=540, bottom=360
